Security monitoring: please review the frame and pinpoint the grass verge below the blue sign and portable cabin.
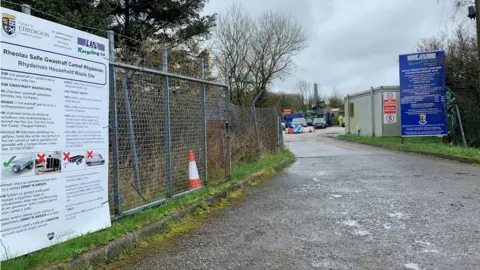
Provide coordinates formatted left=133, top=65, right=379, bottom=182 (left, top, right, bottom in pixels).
left=339, top=135, right=480, bottom=161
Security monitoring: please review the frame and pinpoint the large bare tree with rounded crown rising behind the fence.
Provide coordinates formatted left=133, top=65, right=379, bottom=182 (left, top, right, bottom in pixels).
left=214, top=4, right=308, bottom=105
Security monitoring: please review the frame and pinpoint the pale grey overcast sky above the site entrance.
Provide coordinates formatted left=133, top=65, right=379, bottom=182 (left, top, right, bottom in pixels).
left=205, top=0, right=464, bottom=95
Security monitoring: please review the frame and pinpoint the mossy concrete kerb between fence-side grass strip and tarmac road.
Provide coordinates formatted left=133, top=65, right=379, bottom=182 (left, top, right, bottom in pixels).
left=45, top=159, right=294, bottom=270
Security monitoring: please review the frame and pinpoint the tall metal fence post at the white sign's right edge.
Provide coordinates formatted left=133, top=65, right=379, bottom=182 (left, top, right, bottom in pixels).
left=107, top=30, right=122, bottom=215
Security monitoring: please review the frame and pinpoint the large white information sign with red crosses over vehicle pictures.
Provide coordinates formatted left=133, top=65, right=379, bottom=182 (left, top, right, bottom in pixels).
left=0, top=8, right=111, bottom=261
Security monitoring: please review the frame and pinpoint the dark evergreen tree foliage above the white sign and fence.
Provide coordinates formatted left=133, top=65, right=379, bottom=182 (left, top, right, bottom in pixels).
left=2, top=0, right=216, bottom=44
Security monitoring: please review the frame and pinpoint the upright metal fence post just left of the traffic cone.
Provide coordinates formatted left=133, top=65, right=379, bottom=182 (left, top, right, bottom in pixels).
left=162, top=45, right=172, bottom=197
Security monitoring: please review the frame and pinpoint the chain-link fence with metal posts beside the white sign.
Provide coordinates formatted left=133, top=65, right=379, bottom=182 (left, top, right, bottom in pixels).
left=109, top=38, right=281, bottom=218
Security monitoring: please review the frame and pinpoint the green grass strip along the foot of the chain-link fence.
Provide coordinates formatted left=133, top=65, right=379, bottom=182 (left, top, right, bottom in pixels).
left=0, top=149, right=294, bottom=270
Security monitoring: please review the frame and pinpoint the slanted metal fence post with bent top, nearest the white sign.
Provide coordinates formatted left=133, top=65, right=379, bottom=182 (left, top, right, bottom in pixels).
left=122, top=59, right=142, bottom=193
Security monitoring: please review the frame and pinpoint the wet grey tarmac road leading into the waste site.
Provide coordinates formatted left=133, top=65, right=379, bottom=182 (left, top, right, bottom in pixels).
left=117, top=130, right=480, bottom=270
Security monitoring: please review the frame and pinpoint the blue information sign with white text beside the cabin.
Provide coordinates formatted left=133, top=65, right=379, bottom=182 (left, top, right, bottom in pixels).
left=399, top=51, right=447, bottom=137
